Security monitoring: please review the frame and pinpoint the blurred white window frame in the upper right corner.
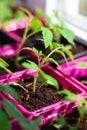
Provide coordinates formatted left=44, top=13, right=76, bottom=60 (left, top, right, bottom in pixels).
left=46, top=0, right=87, bottom=45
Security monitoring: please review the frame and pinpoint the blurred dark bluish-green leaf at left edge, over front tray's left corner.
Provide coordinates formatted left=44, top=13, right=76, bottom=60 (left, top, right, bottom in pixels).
left=0, top=85, right=19, bottom=100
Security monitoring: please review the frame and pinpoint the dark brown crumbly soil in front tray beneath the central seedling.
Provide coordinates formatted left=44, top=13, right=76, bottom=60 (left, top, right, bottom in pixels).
left=12, top=79, right=64, bottom=111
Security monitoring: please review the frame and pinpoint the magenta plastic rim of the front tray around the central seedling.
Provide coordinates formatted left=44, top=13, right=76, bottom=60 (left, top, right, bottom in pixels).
left=0, top=61, right=85, bottom=124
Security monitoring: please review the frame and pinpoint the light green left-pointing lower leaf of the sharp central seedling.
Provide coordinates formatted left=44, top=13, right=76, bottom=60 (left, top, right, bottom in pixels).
left=22, top=60, right=38, bottom=71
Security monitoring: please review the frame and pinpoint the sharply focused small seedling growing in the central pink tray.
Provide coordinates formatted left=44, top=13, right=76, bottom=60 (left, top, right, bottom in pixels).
left=22, top=48, right=59, bottom=92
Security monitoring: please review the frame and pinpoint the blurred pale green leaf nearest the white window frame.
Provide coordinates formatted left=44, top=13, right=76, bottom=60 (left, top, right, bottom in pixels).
left=58, top=25, right=75, bottom=45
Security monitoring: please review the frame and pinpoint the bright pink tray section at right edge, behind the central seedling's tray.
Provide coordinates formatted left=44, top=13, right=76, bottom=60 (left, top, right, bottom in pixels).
left=57, top=56, right=87, bottom=78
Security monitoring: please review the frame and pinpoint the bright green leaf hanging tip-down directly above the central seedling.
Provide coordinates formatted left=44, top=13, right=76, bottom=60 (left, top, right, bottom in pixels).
left=41, top=27, right=53, bottom=48
